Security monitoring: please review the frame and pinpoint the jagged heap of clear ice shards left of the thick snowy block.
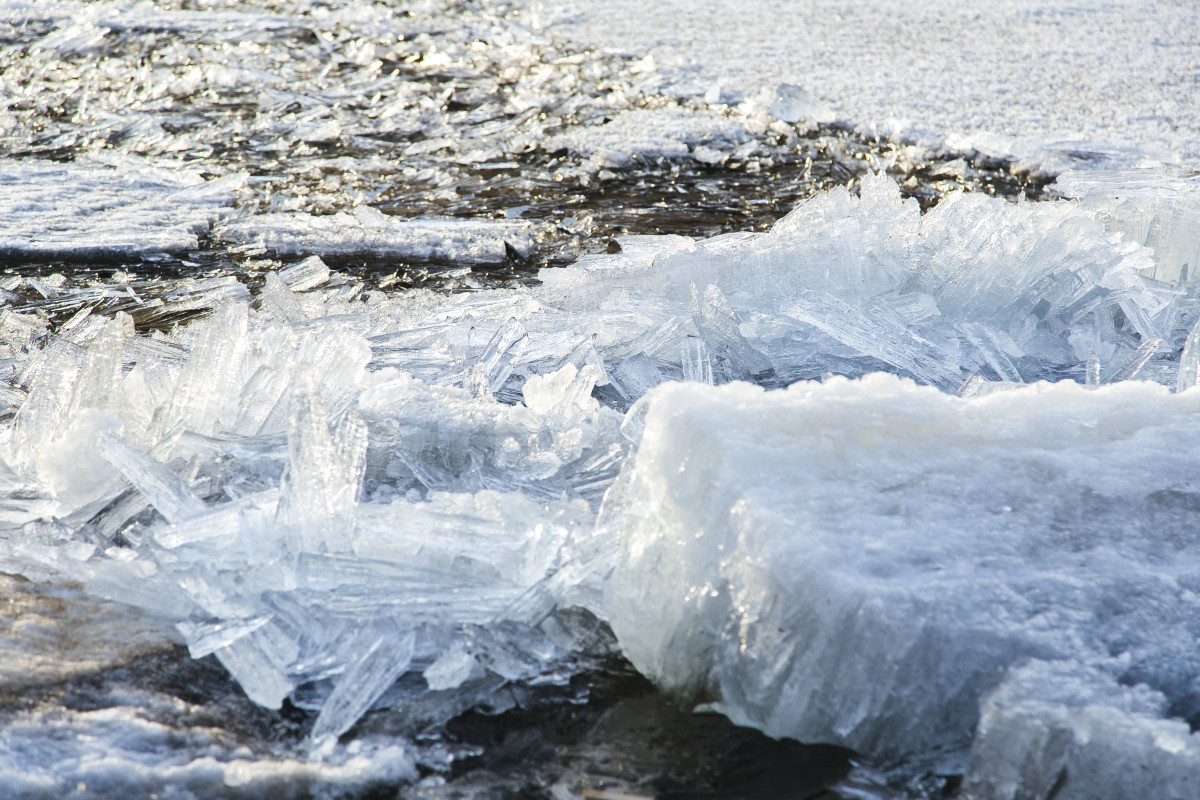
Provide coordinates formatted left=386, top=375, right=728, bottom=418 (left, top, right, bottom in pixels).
left=4, top=293, right=620, bottom=741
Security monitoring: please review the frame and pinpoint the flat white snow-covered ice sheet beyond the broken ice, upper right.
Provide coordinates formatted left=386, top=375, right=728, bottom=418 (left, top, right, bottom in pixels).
left=540, top=0, right=1200, bottom=172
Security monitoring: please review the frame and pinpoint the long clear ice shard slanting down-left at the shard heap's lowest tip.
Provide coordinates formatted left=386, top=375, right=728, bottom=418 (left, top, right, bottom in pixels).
left=311, top=625, right=416, bottom=745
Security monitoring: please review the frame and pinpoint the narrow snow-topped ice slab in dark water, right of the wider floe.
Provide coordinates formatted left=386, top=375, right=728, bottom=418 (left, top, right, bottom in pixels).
left=215, top=206, right=535, bottom=264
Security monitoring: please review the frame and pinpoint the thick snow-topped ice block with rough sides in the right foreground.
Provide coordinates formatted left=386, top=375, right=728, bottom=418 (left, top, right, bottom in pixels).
left=600, top=374, right=1200, bottom=798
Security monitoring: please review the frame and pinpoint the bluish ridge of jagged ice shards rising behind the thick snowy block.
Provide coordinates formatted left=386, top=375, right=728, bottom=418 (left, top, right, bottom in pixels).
left=542, top=175, right=1186, bottom=396
